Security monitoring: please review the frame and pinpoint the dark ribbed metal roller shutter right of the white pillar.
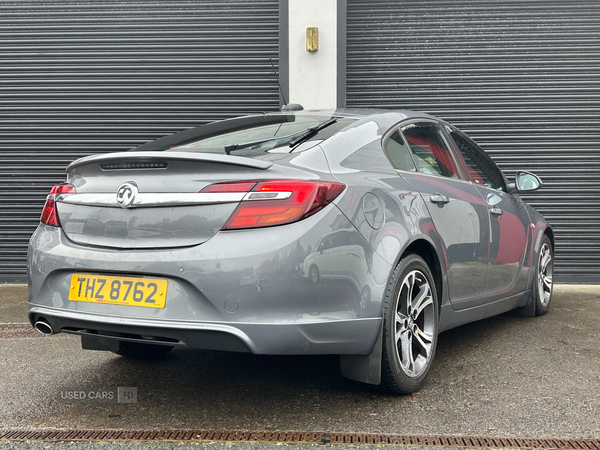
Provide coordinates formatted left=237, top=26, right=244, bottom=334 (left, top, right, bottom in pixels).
left=346, top=0, right=600, bottom=283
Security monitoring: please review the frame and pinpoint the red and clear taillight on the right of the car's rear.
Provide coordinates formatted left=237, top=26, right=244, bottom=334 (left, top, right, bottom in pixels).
left=201, top=180, right=346, bottom=230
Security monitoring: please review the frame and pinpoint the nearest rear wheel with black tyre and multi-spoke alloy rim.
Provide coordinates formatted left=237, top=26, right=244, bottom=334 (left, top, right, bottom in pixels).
left=381, top=253, right=439, bottom=394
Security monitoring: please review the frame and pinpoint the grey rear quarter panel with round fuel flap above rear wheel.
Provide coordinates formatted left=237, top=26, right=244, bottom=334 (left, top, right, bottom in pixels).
left=322, top=113, right=447, bottom=310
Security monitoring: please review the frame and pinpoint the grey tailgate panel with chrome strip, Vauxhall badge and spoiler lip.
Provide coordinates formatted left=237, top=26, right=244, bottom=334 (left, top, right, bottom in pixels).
left=56, top=152, right=272, bottom=249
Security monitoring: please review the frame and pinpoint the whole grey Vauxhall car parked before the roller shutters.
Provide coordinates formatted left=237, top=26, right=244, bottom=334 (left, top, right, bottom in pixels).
left=28, top=110, right=554, bottom=393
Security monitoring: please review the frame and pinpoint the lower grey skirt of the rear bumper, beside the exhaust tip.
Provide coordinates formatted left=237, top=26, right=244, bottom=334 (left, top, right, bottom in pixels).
left=29, top=305, right=381, bottom=355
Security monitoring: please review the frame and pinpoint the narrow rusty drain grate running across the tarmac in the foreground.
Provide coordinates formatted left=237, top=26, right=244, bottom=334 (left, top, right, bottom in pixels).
left=0, top=430, right=600, bottom=450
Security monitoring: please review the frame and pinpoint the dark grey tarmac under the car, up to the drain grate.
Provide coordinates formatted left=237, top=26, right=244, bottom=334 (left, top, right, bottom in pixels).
left=0, top=285, right=600, bottom=438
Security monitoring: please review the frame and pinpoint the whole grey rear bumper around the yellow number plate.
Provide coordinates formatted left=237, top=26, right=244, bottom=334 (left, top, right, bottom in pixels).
left=28, top=206, right=391, bottom=354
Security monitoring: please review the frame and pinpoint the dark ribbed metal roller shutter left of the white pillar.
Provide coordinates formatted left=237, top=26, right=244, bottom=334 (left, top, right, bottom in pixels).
left=0, top=0, right=279, bottom=281
